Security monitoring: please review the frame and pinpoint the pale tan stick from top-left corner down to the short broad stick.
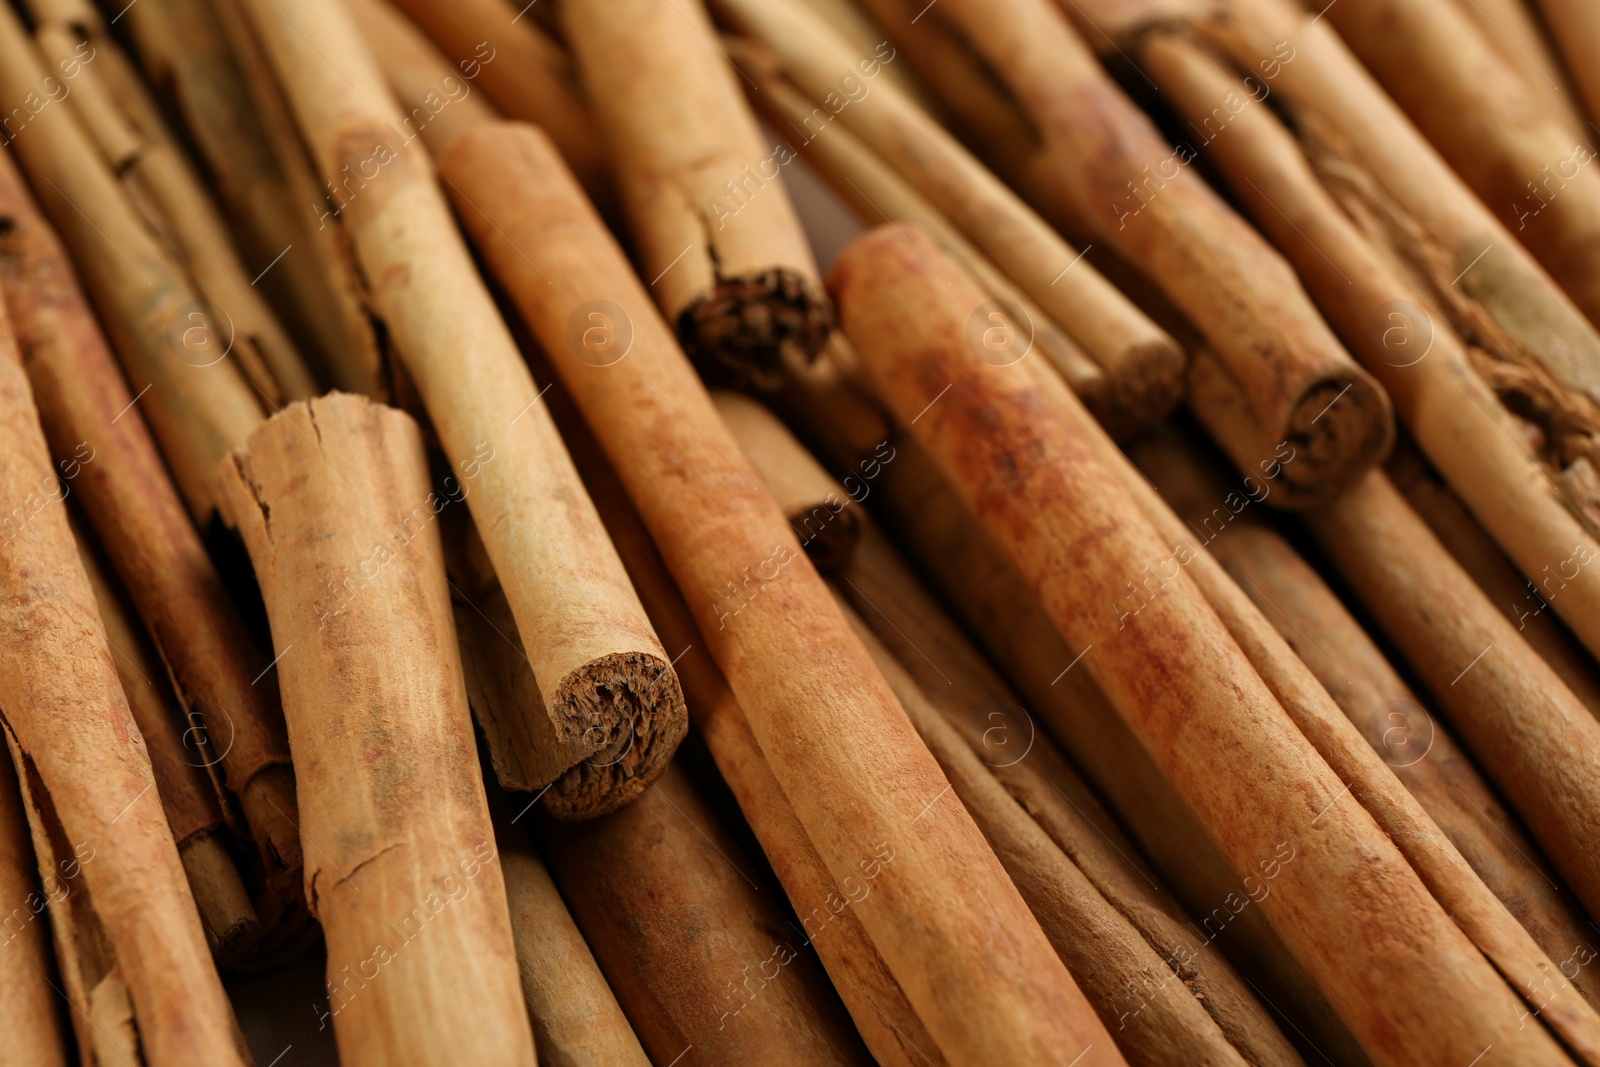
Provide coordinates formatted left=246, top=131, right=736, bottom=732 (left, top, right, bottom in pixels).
left=0, top=0, right=261, bottom=525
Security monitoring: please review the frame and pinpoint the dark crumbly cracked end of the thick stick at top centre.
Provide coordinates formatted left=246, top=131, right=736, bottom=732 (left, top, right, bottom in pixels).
left=677, top=267, right=835, bottom=390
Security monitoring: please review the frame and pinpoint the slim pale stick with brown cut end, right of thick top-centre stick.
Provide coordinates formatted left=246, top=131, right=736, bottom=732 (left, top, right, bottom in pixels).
left=715, top=0, right=1184, bottom=419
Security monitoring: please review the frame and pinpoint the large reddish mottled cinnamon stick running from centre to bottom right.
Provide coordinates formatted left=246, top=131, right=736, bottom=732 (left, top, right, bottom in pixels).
left=830, top=220, right=1565, bottom=1064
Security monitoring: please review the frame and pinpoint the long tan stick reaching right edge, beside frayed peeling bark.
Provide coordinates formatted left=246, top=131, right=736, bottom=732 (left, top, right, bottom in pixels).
left=1141, top=34, right=1600, bottom=675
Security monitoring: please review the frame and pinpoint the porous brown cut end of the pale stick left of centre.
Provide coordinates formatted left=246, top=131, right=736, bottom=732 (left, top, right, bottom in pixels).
left=544, top=653, right=688, bottom=821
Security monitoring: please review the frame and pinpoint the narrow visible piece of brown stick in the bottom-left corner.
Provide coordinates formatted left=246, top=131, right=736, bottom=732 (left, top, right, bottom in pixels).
left=0, top=752, right=67, bottom=1067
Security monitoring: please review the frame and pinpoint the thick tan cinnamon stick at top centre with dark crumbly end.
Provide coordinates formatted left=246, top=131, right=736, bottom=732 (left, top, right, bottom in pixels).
left=558, top=0, right=834, bottom=387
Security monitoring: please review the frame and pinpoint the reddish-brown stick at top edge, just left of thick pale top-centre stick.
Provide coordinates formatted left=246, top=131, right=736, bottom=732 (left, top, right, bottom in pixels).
left=384, top=0, right=613, bottom=206
